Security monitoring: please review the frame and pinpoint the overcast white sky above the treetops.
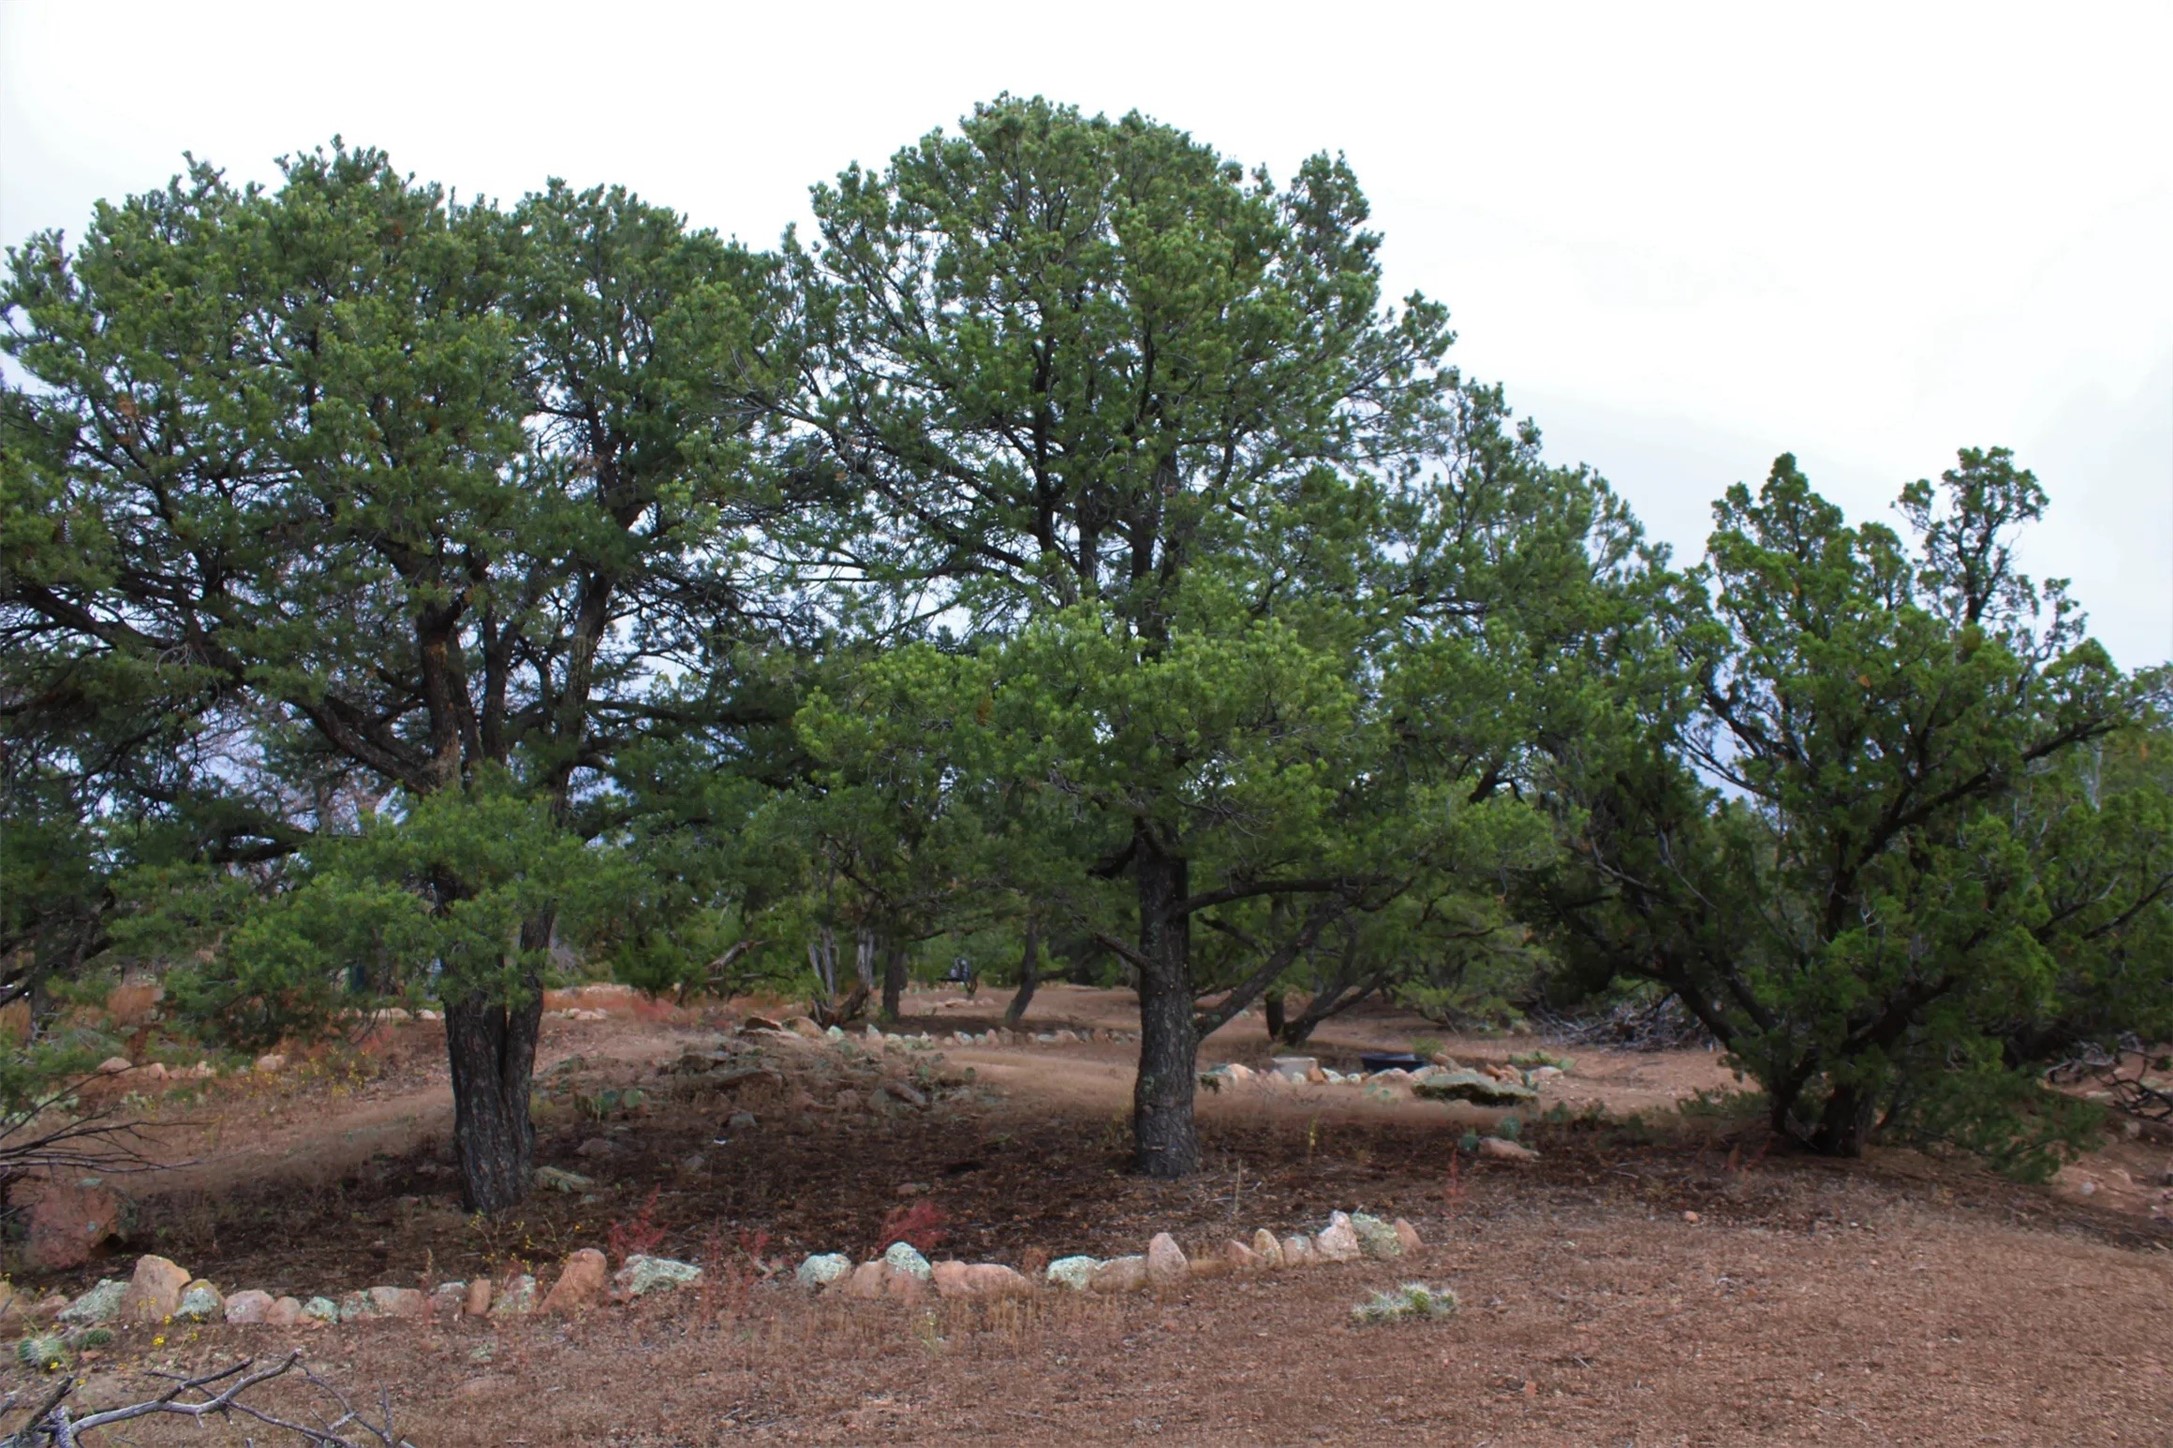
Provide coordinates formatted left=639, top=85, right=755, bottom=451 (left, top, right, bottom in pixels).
left=0, top=0, right=2173, bottom=665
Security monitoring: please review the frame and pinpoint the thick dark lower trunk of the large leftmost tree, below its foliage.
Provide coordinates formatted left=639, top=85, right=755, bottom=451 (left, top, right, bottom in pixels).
left=445, top=978, right=543, bottom=1215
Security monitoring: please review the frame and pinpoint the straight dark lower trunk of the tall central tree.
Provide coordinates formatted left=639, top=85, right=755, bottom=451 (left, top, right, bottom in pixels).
left=1132, top=831, right=1199, bottom=1178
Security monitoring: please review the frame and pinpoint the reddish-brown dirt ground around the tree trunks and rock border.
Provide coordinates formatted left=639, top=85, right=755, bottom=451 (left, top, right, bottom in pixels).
left=0, top=987, right=2173, bottom=1448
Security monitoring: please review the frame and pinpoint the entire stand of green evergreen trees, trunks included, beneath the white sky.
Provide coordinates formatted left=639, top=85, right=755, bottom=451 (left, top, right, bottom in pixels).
left=0, top=98, right=2173, bottom=1211
